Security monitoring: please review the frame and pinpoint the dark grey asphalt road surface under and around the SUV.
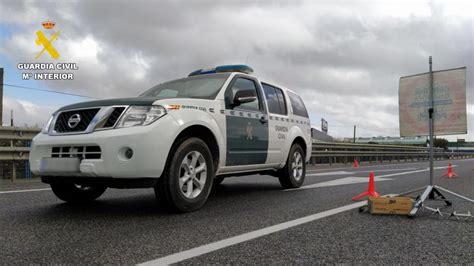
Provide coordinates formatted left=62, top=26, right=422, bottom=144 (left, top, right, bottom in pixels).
left=0, top=160, right=474, bottom=264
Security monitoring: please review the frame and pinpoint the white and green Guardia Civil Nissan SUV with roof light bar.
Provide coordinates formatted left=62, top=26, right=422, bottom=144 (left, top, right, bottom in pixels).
left=29, top=65, right=311, bottom=212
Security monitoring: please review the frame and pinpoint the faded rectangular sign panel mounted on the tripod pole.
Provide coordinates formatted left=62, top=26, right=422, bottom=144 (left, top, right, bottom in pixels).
left=399, top=67, right=467, bottom=136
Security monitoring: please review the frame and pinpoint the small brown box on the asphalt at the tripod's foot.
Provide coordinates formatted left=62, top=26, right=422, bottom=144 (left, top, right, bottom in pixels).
left=368, top=197, right=415, bottom=215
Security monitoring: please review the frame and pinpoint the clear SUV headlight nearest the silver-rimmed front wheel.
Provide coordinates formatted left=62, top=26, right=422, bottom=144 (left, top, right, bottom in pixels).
left=116, top=105, right=166, bottom=128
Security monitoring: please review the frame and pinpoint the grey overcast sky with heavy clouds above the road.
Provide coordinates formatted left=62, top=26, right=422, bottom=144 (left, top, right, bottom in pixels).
left=0, top=0, right=474, bottom=141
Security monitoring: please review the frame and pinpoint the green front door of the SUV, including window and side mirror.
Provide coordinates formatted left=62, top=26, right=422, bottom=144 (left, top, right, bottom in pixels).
left=225, top=75, right=268, bottom=166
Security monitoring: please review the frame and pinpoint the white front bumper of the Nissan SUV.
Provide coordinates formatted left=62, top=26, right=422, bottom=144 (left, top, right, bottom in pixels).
left=29, top=115, right=178, bottom=178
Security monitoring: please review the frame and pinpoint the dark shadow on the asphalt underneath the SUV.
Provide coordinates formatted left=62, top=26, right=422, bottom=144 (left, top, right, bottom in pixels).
left=31, top=181, right=281, bottom=220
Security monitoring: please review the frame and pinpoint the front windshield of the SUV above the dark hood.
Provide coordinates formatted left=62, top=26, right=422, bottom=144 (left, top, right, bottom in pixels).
left=139, top=73, right=230, bottom=99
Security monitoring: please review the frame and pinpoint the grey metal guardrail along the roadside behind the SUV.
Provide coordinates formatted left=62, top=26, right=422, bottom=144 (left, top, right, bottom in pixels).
left=0, top=127, right=474, bottom=181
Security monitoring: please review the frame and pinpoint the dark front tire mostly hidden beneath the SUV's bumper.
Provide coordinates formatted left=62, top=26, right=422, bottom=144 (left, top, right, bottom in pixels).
left=51, top=183, right=107, bottom=203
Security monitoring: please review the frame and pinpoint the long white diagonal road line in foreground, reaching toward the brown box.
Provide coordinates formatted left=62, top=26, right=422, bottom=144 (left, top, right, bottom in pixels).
left=139, top=201, right=367, bottom=265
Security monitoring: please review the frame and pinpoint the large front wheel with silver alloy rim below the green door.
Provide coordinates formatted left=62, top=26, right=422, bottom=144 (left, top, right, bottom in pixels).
left=155, top=138, right=214, bottom=212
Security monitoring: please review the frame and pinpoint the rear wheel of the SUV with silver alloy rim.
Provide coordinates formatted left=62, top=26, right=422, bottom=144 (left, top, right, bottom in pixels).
left=278, top=144, right=306, bottom=189
